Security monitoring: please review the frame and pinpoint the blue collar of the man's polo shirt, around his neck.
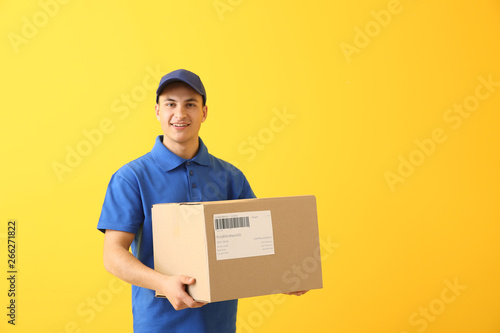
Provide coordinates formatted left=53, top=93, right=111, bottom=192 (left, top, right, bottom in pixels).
left=151, top=135, right=210, bottom=172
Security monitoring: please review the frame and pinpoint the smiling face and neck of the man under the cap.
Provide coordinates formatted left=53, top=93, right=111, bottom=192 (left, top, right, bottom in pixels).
left=155, top=82, right=208, bottom=159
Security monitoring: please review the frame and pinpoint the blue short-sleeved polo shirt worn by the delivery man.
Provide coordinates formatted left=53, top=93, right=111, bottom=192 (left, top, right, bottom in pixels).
left=97, top=135, right=255, bottom=333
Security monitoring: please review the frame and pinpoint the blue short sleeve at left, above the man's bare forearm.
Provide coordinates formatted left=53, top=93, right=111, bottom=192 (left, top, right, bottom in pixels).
left=97, top=172, right=144, bottom=234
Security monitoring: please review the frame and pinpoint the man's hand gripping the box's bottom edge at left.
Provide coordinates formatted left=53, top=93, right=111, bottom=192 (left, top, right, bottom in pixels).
left=158, top=275, right=205, bottom=310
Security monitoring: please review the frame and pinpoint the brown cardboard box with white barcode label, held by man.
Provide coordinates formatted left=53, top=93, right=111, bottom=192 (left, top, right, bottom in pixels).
left=152, top=196, right=323, bottom=302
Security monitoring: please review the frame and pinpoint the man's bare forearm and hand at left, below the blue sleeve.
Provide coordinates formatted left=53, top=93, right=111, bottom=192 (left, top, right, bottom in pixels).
left=104, top=229, right=204, bottom=310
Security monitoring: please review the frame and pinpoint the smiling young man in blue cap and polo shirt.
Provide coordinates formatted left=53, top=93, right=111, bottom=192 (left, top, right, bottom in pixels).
left=97, top=69, right=301, bottom=333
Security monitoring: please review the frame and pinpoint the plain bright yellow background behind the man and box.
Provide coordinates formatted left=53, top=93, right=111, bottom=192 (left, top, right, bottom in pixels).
left=0, top=0, right=500, bottom=333
